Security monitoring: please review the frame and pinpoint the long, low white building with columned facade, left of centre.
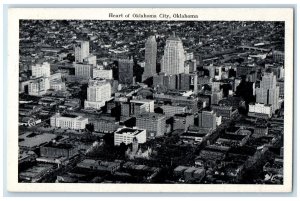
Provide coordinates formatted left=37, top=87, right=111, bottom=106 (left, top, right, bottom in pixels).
left=50, top=113, right=89, bottom=130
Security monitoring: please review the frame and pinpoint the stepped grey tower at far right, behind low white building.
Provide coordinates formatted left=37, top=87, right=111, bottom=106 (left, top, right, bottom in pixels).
left=256, top=72, right=279, bottom=113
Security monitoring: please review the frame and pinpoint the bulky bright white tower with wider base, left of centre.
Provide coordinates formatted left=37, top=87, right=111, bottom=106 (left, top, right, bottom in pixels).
left=84, top=79, right=111, bottom=109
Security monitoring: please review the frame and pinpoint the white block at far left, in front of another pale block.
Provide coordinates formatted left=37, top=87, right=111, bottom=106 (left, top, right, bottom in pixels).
left=28, top=77, right=50, bottom=96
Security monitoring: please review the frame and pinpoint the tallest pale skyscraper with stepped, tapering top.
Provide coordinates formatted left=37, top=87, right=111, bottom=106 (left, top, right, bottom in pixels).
left=161, top=34, right=185, bottom=75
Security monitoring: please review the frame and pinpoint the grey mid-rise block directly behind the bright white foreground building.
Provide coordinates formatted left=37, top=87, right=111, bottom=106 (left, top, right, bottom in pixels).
left=136, top=113, right=166, bottom=138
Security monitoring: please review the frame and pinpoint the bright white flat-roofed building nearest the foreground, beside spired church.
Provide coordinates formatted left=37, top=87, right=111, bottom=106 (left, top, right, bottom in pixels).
left=114, top=128, right=147, bottom=146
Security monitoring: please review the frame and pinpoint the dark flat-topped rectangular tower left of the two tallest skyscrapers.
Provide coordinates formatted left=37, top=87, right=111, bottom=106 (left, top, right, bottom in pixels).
left=119, top=59, right=133, bottom=85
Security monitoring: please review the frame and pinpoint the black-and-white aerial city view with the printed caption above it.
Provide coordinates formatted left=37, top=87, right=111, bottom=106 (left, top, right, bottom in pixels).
left=5, top=7, right=293, bottom=193
